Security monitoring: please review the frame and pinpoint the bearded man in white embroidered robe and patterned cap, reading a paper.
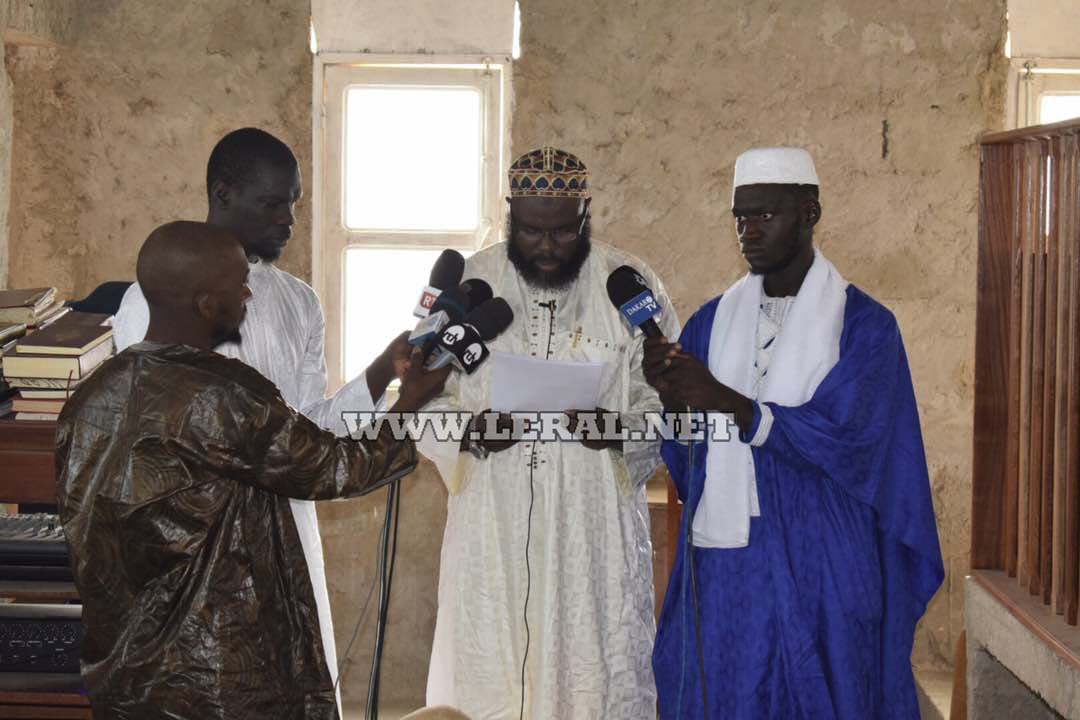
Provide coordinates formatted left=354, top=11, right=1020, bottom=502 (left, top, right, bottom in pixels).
left=418, top=148, right=678, bottom=720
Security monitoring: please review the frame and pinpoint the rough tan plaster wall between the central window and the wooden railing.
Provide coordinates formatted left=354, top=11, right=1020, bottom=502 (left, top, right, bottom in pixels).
left=513, top=0, right=1004, bottom=666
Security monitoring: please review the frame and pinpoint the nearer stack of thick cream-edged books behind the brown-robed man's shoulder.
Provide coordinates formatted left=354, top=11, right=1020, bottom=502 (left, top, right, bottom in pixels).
left=3, top=312, right=113, bottom=420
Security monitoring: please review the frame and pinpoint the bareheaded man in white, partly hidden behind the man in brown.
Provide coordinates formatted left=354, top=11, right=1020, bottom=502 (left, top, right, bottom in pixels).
left=113, top=127, right=408, bottom=708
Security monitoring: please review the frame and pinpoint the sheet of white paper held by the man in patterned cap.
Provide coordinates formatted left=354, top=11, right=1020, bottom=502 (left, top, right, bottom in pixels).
left=488, top=352, right=604, bottom=412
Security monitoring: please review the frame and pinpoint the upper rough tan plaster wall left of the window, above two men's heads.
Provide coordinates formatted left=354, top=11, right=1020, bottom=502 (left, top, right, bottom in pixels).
left=8, top=0, right=311, bottom=297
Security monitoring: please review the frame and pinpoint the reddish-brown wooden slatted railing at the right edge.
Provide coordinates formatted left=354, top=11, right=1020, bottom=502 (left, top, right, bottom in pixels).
left=971, top=121, right=1080, bottom=625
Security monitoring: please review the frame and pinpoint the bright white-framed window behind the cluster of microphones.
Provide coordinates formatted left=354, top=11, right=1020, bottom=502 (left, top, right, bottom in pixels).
left=314, top=56, right=509, bottom=386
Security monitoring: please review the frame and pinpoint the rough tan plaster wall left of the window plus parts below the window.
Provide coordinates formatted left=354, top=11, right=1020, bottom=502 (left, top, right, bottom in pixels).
left=0, top=0, right=445, bottom=708
